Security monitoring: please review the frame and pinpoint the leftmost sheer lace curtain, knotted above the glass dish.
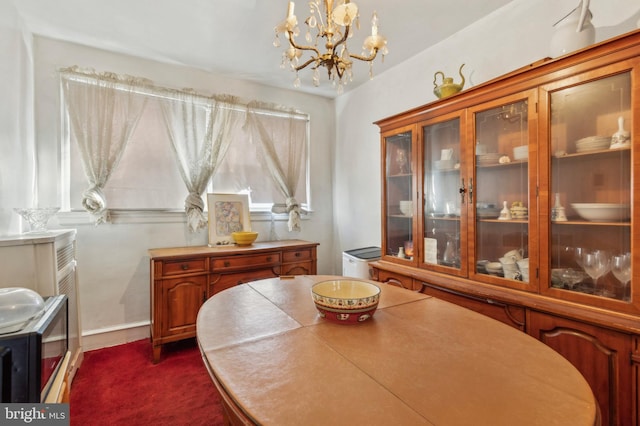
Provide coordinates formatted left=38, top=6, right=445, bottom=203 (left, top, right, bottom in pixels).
left=60, top=67, right=149, bottom=225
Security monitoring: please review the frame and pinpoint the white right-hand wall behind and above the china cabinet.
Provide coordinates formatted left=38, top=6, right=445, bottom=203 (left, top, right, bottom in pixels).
left=333, top=0, right=640, bottom=270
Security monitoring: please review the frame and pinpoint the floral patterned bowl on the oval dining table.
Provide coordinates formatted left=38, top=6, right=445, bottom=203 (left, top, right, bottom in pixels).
left=311, top=279, right=380, bottom=324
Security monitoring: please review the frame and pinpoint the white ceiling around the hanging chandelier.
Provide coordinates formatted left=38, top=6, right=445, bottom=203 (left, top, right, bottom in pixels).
left=13, top=0, right=512, bottom=97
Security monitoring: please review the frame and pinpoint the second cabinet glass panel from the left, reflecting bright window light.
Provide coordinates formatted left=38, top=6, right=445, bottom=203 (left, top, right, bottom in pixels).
left=422, top=118, right=461, bottom=268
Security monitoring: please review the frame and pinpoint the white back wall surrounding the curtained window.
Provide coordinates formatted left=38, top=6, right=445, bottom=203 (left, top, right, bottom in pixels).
left=5, top=37, right=335, bottom=349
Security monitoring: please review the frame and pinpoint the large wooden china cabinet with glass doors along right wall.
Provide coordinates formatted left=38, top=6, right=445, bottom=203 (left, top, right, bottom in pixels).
left=371, top=31, right=640, bottom=425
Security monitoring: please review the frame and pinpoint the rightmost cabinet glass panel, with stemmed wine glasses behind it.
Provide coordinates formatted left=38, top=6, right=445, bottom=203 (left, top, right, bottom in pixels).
left=549, top=73, right=631, bottom=301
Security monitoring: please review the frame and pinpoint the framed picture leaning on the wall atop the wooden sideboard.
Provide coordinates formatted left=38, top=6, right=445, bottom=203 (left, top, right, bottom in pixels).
left=207, top=194, right=251, bottom=247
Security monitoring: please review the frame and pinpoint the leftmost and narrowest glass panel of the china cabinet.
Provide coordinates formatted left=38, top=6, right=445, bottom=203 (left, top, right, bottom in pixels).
left=385, top=132, right=415, bottom=259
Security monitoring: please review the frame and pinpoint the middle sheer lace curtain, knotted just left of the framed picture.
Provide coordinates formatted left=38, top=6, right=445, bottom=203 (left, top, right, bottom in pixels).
left=161, top=91, right=244, bottom=232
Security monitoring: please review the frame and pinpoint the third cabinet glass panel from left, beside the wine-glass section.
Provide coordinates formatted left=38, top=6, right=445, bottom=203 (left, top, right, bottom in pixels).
left=473, top=100, right=529, bottom=283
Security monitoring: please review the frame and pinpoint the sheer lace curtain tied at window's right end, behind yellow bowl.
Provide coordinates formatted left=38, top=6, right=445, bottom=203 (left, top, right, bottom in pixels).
left=245, top=102, right=307, bottom=232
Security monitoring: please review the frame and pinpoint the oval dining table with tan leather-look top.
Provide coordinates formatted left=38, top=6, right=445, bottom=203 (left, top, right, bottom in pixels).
left=197, top=275, right=600, bottom=426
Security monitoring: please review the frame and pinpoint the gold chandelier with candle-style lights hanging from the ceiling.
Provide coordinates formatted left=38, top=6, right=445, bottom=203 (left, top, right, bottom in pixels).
left=273, top=0, right=388, bottom=94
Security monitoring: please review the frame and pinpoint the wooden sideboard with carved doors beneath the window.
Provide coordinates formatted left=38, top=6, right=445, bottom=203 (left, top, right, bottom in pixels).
left=149, top=240, right=318, bottom=362
